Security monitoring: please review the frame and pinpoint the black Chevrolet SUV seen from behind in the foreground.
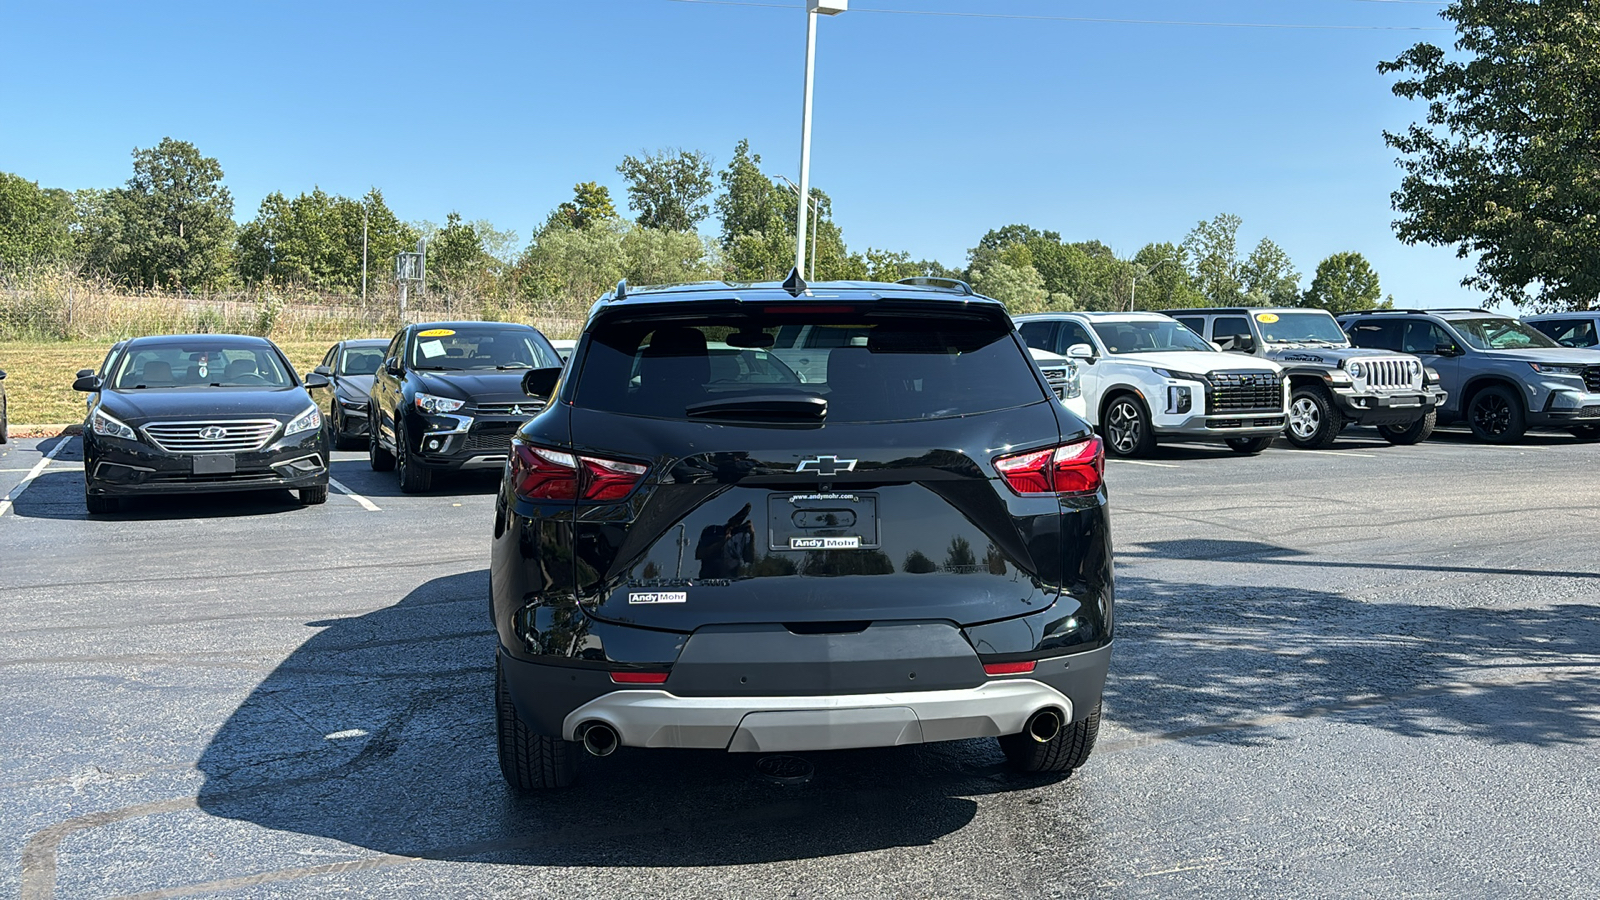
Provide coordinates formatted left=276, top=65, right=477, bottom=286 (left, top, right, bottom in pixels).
left=490, top=275, right=1114, bottom=790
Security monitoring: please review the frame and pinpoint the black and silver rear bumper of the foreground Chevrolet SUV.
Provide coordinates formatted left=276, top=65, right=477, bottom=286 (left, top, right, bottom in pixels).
left=501, top=645, right=1110, bottom=753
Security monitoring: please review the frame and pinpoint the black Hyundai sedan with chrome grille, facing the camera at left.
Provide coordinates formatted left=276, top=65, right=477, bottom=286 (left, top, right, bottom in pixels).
left=72, top=335, right=328, bottom=514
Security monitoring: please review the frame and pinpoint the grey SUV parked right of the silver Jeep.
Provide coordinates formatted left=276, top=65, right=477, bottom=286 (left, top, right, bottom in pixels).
left=1339, top=309, right=1600, bottom=444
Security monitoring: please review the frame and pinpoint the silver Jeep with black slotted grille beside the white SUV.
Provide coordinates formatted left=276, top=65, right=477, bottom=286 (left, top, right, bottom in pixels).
left=1166, top=306, right=1445, bottom=450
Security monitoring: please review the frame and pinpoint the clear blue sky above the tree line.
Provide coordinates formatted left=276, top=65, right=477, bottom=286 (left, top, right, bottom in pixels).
left=0, top=0, right=1478, bottom=306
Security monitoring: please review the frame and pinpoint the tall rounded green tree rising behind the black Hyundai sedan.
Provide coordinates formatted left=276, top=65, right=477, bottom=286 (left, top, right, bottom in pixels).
left=112, top=138, right=234, bottom=288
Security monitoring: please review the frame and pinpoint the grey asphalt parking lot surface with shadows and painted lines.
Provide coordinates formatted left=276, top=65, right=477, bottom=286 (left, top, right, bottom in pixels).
left=0, top=431, right=1600, bottom=900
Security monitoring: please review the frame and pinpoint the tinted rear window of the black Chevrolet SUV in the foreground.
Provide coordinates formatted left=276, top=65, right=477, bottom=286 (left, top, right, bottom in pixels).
left=574, top=312, right=1048, bottom=423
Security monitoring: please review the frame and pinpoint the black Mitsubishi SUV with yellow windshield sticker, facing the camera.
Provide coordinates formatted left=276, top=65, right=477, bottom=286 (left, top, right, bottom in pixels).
left=366, top=322, right=562, bottom=493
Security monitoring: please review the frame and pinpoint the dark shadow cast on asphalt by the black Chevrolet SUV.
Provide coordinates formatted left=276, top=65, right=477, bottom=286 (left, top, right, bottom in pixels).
left=198, top=572, right=1061, bottom=866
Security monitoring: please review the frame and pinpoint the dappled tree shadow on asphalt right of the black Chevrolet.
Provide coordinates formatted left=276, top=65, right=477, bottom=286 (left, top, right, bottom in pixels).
left=1106, top=540, right=1600, bottom=746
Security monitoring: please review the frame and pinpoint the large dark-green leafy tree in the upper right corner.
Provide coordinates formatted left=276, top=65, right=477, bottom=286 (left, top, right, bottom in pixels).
left=1378, top=0, right=1600, bottom=307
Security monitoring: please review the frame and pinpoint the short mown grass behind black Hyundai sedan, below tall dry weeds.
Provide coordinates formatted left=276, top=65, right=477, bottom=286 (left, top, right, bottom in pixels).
left=0, top=335, right=363, bottom=431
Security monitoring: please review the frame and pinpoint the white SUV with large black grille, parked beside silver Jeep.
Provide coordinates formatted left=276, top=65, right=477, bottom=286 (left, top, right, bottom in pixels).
left=1016, top=312, right=1290, bottom=456
